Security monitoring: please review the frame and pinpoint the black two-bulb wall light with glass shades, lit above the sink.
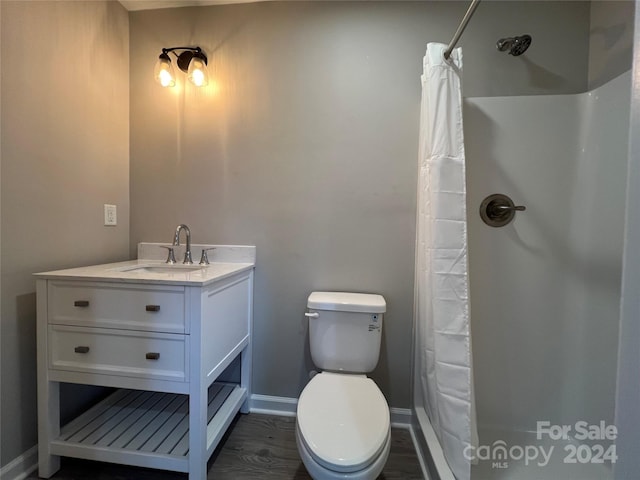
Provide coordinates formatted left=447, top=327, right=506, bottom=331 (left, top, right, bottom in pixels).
left=154, top=47, right=209, bottom=87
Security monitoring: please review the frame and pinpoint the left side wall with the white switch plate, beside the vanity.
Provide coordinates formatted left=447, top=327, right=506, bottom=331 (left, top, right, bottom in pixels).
left=0, top=0, right=129, bottom=465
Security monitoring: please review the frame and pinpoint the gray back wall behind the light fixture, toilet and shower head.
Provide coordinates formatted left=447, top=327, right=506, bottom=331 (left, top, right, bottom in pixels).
left=130, top=2, right=589, bottom=408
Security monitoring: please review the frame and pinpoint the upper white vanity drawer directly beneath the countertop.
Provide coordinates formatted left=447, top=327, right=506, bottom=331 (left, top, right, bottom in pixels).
left=47, top=281, right=188, bottom=333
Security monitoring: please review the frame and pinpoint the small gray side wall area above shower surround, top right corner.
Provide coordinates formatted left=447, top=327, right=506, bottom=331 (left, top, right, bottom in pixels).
left=589, top=0, right=635, bottom=90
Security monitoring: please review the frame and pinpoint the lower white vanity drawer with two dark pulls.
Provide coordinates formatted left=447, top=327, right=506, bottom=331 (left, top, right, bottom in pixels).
left=48, top=325, right=189, bottom=382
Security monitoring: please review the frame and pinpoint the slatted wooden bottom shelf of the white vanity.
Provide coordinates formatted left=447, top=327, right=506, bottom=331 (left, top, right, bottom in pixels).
left=51, top=383, right=247, bottom=472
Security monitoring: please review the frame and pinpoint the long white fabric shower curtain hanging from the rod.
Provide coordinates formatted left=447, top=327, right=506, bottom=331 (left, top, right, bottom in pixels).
left=415, top=43, right=477, bottom=480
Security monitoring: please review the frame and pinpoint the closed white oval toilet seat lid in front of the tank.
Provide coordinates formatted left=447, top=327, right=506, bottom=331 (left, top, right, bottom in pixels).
left=297, top=372, right=390, bottom=472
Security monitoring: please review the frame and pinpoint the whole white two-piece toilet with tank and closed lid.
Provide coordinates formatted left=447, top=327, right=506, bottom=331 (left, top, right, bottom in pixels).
left=296, top=292, right=391, bottom=480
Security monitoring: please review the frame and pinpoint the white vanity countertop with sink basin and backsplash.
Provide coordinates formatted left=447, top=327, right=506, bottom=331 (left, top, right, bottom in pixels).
left=35, top=244, right=255, bottom=286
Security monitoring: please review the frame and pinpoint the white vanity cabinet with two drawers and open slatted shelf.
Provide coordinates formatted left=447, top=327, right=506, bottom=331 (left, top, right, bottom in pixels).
left=37, top=255, right=253, bottom=480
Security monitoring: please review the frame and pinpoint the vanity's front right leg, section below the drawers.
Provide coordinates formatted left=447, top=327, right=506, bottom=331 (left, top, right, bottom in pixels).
left=189, top=388, right=207, bottom=480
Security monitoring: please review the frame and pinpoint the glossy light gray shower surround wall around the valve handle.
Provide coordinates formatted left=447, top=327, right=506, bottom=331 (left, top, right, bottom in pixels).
left=464, top=72, right=631, bottom=479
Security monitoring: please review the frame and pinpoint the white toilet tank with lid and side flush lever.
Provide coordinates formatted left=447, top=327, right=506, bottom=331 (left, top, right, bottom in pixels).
left=306, top=292, right=387, bottom=373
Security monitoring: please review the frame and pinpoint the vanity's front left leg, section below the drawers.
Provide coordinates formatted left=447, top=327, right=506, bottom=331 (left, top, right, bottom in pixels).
left=38, top=381, right=60, bottom=478
